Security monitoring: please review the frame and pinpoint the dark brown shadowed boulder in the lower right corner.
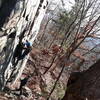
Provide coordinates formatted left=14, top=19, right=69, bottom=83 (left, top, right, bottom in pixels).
left=62, top=60, right=100, bottom=100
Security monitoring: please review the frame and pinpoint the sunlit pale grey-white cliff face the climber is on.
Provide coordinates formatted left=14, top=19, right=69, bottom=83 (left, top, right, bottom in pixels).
left=0, top=0, right=48, bottom=90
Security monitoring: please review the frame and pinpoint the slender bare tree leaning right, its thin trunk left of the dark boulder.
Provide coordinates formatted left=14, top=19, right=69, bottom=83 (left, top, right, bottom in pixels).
left=47, top=0, right=100, bottom=100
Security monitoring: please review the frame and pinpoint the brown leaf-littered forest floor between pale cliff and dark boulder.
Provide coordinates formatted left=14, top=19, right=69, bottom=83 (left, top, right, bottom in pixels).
left=0, top=48, right=70, bottom=100
